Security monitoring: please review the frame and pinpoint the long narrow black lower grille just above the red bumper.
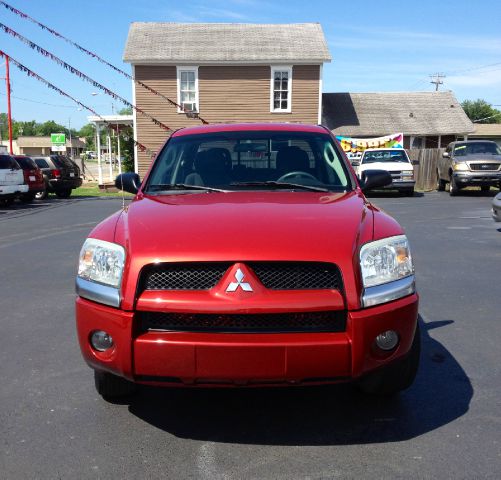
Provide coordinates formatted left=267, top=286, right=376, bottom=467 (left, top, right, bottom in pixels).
left=137, top=311, right=346, bottom=333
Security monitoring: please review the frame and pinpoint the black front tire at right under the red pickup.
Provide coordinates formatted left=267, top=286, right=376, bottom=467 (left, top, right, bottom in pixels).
left=356, top=324, right=421, bottom=395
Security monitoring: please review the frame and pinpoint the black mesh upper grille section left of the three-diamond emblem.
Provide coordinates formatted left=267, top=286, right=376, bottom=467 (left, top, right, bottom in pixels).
left=141, top=262, right=231, bottom=290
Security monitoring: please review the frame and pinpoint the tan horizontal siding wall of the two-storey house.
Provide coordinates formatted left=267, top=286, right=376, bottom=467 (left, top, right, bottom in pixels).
left=134, top=65, right=320, bottom=176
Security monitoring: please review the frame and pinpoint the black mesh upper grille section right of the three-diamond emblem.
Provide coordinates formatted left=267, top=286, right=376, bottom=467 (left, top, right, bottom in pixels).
left=248, top=262, right=342, bottom=290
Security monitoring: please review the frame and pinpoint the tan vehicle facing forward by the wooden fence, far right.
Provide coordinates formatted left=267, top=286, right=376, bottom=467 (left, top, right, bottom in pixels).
left=437, top=140, right=501, bottom=196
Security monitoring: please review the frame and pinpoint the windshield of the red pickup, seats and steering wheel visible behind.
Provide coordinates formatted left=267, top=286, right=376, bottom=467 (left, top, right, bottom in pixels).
left=145, top=131, right=352, bottom=193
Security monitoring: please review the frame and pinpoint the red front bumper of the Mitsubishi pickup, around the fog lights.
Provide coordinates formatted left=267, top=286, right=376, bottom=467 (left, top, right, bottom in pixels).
left=76, top=294, right=418, bottom=386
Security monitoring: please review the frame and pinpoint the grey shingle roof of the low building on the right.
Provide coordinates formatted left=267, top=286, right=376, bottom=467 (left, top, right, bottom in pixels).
left=322, top=91, right=475, bottom=137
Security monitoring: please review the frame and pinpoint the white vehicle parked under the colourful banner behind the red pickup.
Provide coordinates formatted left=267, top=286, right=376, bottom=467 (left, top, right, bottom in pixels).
left=352, top=148, right=417, bottom=197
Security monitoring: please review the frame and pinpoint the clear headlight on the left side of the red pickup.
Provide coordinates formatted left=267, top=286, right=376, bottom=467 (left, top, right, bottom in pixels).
left=78, top=238, right=125, bottom=289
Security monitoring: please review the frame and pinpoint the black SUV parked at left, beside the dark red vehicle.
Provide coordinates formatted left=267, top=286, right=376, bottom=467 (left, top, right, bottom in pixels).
left=33, top=155, right=82, bottom=199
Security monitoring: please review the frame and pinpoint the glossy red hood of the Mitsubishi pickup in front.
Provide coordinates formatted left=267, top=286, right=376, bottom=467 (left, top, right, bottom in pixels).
left=116, top=191, right=373, bottom=264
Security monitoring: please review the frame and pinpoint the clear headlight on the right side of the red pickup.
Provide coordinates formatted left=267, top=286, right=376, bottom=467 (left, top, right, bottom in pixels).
left=360, top=235, right=414, bottom=288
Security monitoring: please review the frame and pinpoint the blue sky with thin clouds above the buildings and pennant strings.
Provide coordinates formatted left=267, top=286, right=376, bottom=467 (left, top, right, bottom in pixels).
left=0, top=0, right=501, bottom=129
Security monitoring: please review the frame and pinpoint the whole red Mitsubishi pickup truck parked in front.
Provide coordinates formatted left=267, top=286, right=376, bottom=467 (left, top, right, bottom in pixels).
left=76, top=124, right=420, bottom=398
